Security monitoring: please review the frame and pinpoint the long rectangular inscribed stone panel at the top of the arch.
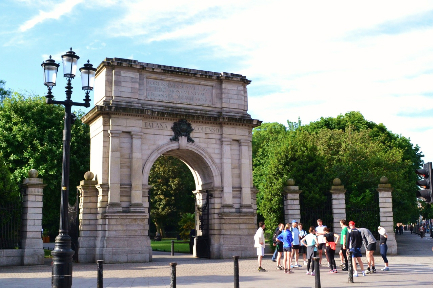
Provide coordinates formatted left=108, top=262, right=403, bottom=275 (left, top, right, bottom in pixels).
left=146, top=79, right=212, bottom=105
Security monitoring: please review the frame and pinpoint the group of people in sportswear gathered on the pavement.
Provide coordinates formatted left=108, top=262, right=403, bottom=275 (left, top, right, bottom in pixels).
left=254, top=219, right=389, bottom=277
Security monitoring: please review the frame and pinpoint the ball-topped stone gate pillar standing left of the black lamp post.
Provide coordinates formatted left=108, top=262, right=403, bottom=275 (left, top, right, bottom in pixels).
left=21, top=169, right=46, bottom=265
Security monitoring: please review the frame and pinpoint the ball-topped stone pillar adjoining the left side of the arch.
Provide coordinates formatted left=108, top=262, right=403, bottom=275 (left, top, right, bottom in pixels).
left=77, top=171, right=99, bottom=263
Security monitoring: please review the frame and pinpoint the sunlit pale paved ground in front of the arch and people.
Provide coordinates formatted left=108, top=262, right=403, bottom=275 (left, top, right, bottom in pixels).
left=0, top=232, right=433, bottom=288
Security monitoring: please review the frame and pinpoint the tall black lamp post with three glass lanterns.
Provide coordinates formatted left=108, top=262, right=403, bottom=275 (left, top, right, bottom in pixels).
left=41, top=48, right=96, bottom=288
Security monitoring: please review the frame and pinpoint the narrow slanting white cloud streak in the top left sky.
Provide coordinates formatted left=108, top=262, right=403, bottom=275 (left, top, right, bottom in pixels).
left=19, top=0, right=84, bottom=32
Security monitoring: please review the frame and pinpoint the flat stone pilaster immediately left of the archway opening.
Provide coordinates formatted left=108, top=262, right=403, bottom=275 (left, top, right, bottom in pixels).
left=130, top=132, right=144, bottom=211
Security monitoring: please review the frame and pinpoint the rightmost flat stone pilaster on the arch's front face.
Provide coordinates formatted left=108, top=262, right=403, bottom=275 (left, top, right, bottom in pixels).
left=239, top=140, right=253, bottom=212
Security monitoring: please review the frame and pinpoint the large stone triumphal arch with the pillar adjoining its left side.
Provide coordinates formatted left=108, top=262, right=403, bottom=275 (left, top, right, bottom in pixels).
left=79, top=58, right=261, bottom=263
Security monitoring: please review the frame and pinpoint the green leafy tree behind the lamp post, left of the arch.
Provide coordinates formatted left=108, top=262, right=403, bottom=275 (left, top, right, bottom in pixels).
left=0, top=92, right=90, bottom=236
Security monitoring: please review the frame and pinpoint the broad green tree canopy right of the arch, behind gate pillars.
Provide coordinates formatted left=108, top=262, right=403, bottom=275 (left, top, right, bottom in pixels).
left=253, top=112, right=422, bottom=235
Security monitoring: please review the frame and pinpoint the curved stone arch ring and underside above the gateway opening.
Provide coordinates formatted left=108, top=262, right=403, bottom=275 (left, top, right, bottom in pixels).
left=142, top=139, right=221, bottom=190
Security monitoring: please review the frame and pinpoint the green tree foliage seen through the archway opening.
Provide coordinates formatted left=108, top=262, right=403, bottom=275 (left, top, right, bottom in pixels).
left=149, top=156, right=195, bottom=236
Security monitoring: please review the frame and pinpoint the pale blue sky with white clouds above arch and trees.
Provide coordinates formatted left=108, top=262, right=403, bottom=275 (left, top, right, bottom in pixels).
left=0, top=0, right=433, bottom=162
